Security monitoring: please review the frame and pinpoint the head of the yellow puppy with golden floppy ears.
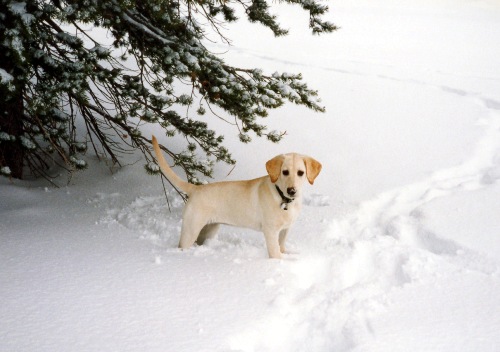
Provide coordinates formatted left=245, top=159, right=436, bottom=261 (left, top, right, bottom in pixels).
left=266, top=153, right=321, bottom=198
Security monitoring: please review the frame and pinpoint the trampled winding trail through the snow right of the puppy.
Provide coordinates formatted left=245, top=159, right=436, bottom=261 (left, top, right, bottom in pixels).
left=229, top=83, right=500, bottom=351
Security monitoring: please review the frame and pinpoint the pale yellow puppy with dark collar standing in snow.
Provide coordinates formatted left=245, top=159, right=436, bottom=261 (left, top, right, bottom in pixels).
left=152, top=136, right=321, bottom=259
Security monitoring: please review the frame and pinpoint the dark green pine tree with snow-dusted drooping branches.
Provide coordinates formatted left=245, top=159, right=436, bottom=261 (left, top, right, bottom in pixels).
left=0, top=0, right=336, bottom=181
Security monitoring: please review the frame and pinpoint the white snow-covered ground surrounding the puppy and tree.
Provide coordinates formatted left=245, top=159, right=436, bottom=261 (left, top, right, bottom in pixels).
left=0, top=0, right=500, bottom=352
